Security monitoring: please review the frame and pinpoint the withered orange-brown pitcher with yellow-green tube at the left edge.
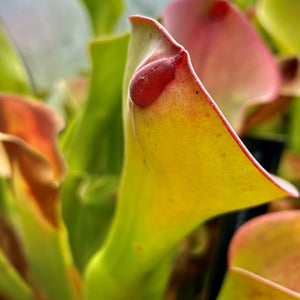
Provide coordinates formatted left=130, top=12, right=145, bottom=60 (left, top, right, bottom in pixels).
left=0, top=94, right=80, bottom=300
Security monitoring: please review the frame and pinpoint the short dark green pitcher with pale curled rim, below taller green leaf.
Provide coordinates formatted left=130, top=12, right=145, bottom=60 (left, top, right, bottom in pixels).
left=61, top=173, right=119, bottom=271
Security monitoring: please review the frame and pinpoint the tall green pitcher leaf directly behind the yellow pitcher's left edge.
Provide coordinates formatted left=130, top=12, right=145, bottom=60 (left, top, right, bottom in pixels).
left=62, top=35, right=129, bottom=174
